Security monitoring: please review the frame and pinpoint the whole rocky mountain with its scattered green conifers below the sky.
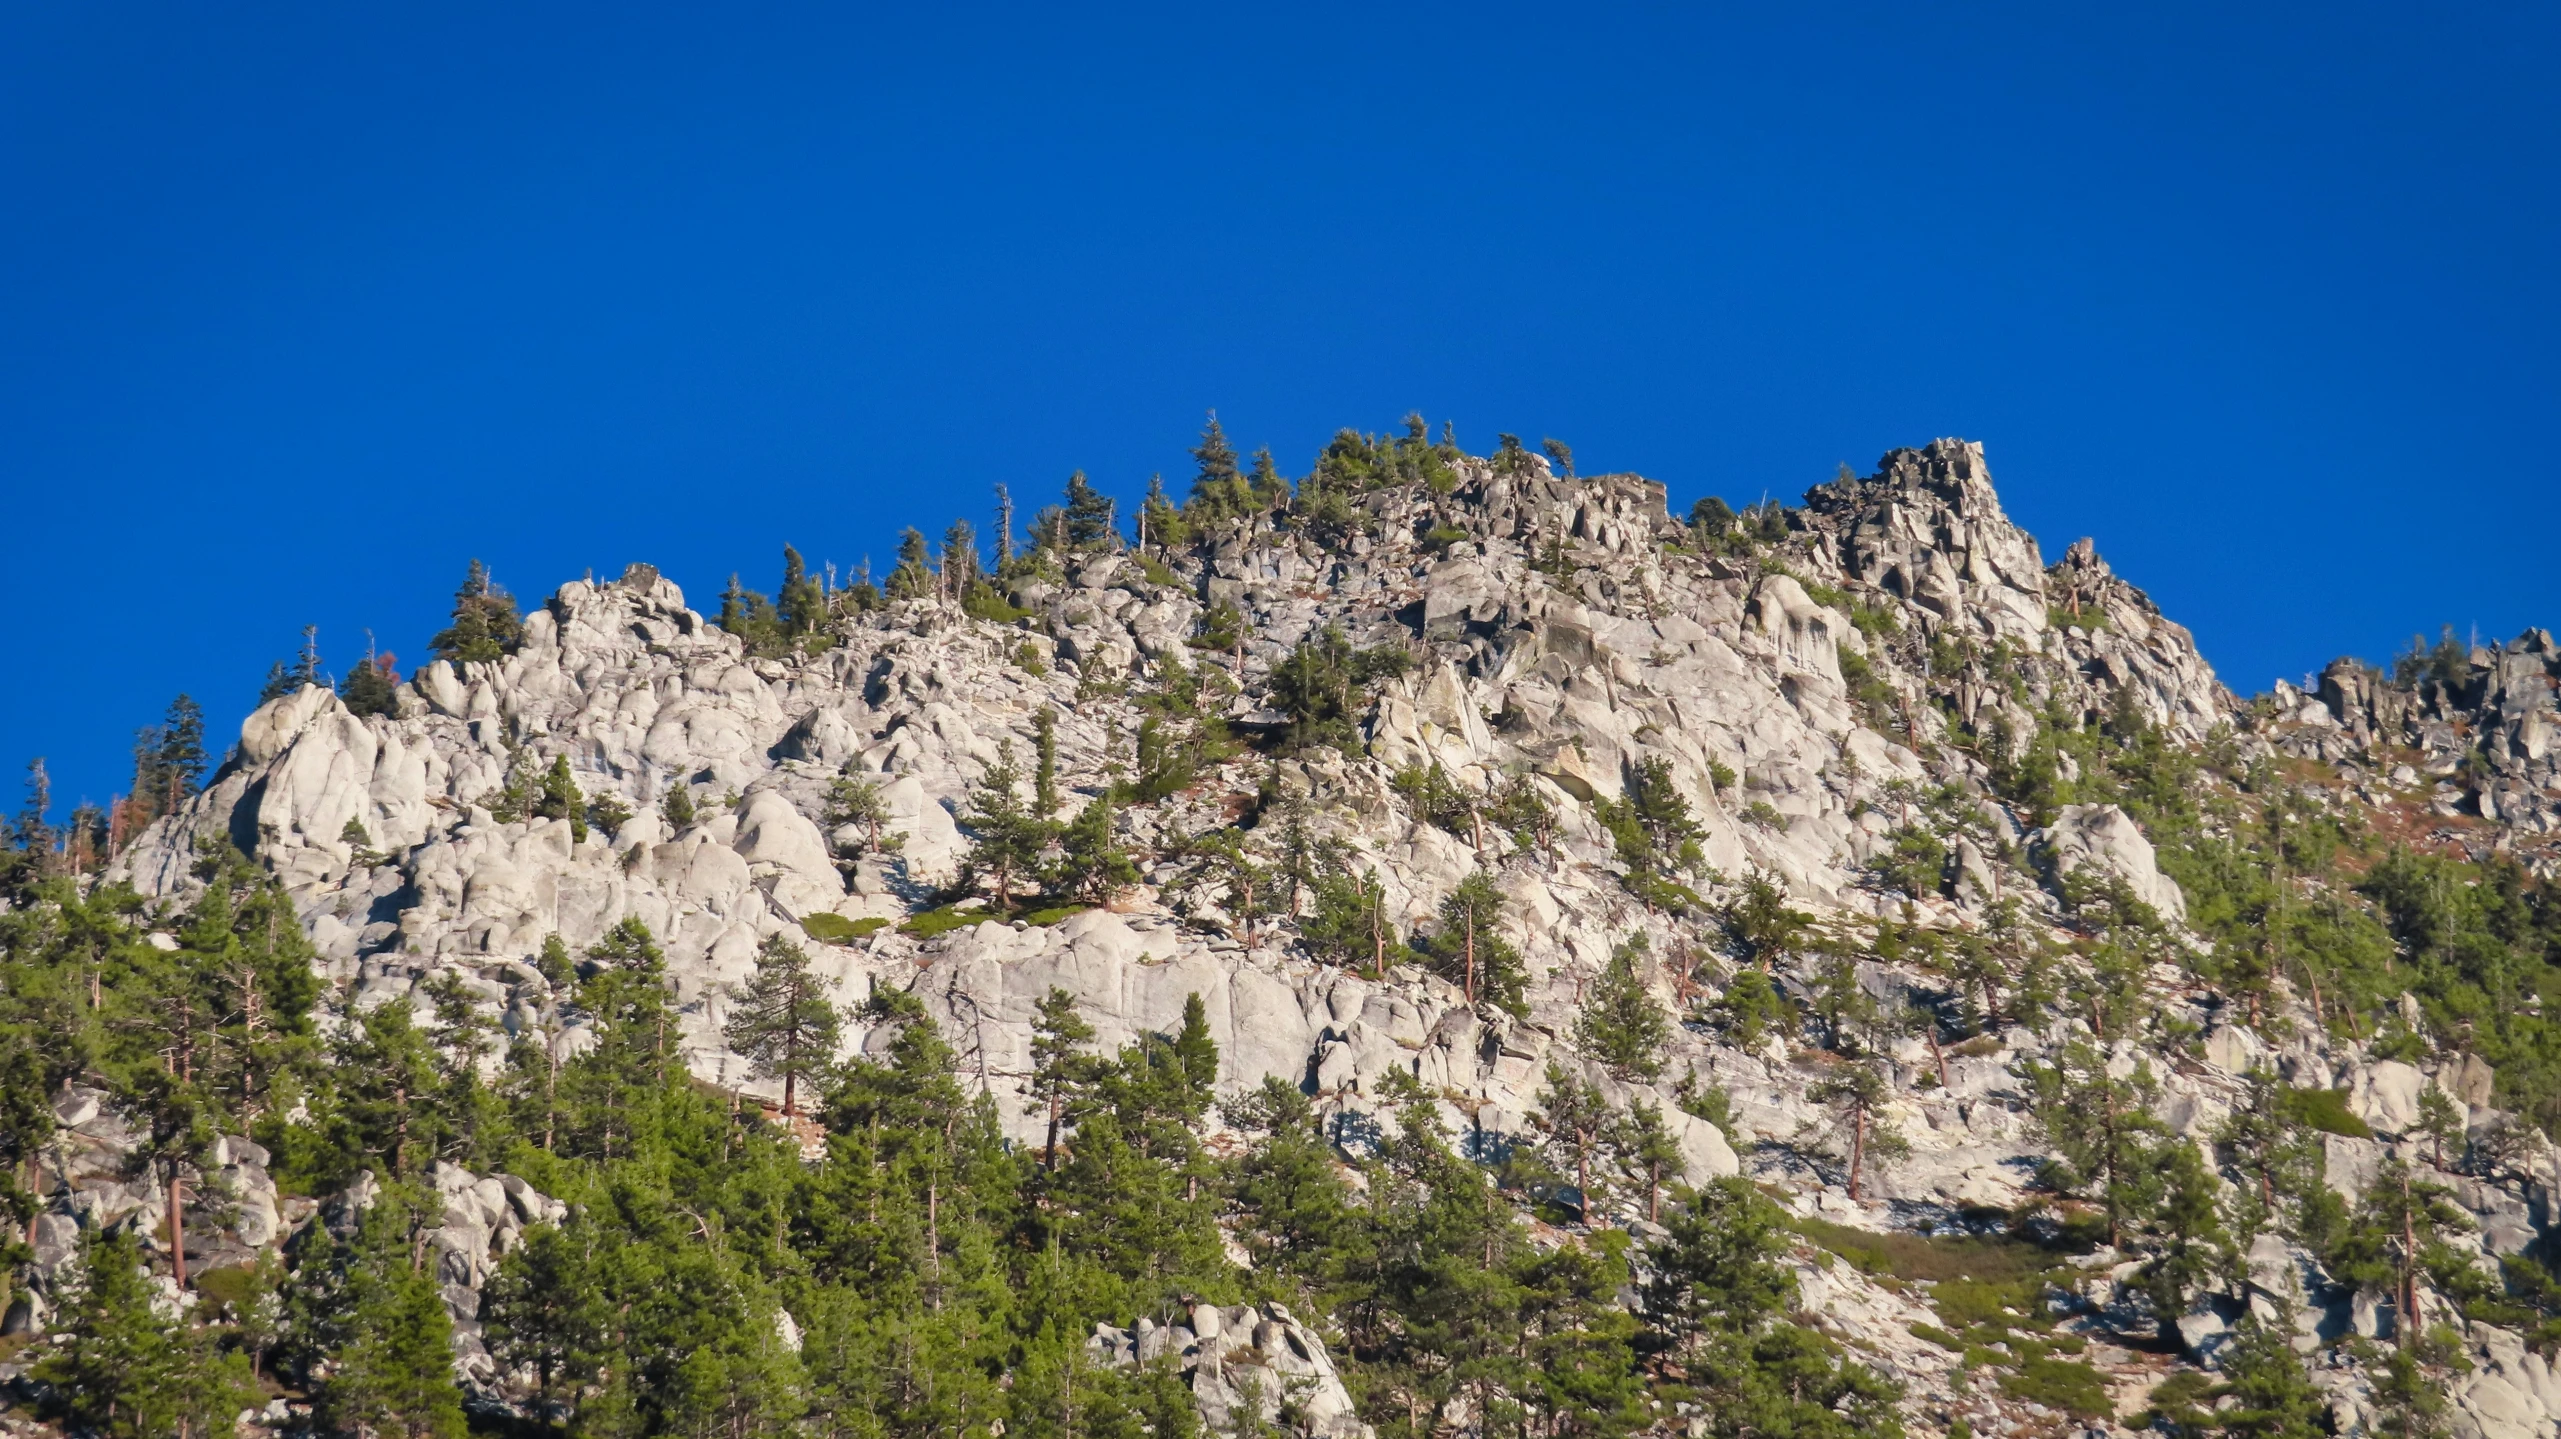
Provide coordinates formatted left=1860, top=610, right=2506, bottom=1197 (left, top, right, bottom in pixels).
left=0, top=420, right=2561, bottom=1439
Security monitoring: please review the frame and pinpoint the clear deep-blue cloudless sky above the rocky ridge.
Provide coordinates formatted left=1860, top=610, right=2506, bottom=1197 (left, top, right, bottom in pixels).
left=0, top=5, right=2561, bottom=809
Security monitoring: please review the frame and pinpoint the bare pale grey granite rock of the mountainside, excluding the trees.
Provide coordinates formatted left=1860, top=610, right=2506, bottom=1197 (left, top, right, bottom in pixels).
left=60, top=440, right=2561, bottom=1439
